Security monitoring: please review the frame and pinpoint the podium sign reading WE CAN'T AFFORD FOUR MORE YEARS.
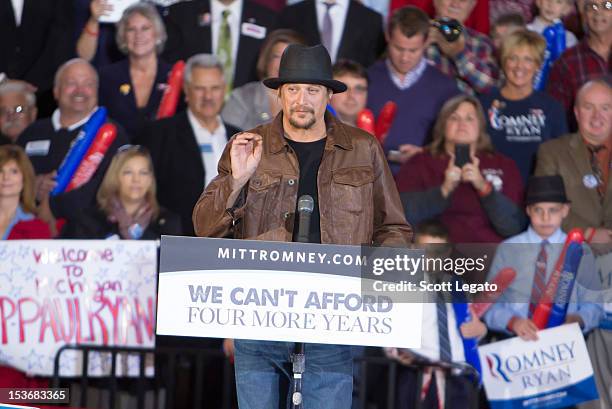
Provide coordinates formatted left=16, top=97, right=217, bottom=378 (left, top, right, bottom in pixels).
left=157, top=236, right=422, bottom=348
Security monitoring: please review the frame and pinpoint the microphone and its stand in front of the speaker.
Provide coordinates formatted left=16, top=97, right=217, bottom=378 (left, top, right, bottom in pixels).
left=289, top=195, right=314, bottom=409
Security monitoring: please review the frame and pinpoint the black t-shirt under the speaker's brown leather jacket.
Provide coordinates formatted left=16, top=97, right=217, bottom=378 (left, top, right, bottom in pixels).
left=286, top=138, right=326, bottom=243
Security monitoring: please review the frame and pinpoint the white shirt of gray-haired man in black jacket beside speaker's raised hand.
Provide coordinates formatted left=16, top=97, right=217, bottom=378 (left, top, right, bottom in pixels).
left=187, top=109, right=227, bottom=186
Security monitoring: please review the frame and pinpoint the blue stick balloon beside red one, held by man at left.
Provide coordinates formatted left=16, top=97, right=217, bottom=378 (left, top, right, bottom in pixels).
left=51, top=107, right=106, bottom=196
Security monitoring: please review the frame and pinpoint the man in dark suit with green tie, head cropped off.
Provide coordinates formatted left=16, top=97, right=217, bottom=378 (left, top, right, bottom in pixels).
left=163, top=0, right=276, bottom=92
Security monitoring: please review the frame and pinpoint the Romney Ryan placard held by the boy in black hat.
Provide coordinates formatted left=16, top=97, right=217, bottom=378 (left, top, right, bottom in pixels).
left=478, top=324, right=598, bottom=409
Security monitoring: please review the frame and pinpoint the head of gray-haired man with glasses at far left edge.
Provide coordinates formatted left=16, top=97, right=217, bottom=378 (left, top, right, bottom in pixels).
left=0, top=80, right=38, bottom=144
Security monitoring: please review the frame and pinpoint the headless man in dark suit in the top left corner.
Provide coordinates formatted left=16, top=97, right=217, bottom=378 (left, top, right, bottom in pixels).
left=0, top=0, right=74, bottom=115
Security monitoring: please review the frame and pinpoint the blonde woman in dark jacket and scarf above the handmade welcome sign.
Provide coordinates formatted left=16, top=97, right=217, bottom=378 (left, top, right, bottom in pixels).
left=62, top=145, right=181, bottom=240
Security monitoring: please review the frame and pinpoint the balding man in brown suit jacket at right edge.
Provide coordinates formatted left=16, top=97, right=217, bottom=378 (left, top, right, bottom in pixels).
left=535, top=79, right=612, bottom=244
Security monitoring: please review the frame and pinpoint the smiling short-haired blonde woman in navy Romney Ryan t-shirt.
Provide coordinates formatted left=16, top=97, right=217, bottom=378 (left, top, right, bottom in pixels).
left=480, top=30, right=568, bottom=183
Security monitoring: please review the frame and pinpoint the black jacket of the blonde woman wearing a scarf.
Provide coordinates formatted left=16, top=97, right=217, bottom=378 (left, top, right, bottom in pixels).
left=61, top=207, right=181, bottom=240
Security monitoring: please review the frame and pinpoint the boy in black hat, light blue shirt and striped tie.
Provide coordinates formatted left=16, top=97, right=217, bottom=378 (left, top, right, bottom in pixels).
left=485, top=175, right=602, bottom=341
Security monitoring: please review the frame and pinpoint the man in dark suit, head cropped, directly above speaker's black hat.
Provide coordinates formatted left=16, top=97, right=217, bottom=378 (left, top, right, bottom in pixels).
left=279, top=0, right=385, bottom=67
